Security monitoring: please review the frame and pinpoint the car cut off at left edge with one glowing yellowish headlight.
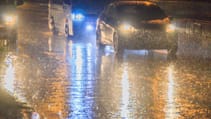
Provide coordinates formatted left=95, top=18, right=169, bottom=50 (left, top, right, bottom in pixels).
left=0, top=0, right=23, bottom=40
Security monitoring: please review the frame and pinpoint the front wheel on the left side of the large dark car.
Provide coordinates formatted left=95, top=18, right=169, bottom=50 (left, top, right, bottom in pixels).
left=113, top=33, right=123, bottom=55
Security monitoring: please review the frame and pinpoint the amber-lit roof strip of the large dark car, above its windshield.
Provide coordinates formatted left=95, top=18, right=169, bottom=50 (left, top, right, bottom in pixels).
left=112, top=0, right=156, bottom=6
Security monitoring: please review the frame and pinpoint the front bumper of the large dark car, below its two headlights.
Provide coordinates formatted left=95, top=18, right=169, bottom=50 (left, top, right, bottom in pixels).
left=119, top=30, right=178, bottom=49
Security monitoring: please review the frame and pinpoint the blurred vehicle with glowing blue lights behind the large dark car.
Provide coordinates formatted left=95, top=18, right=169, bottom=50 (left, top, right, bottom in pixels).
left=71, top=0, right=114, bottom=36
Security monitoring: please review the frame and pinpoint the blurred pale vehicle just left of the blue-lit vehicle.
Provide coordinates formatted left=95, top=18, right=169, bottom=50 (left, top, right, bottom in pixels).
left=48, top=0, right=73, bottom=36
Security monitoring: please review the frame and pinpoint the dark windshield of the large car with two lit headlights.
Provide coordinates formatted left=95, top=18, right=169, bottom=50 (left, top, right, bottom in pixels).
left=117, top=5, right=166, bottom=20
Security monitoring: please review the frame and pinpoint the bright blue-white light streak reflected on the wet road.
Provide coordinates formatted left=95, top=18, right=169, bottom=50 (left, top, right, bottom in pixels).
left=67, top=43, right=96, bottom=119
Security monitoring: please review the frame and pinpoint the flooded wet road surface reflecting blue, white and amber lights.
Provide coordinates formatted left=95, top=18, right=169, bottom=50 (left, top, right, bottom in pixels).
left=0, top=4, right=211, bottom=119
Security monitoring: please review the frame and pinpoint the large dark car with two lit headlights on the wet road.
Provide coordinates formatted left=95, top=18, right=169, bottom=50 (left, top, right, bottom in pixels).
left=96, top=1, right=178, bottom=57
